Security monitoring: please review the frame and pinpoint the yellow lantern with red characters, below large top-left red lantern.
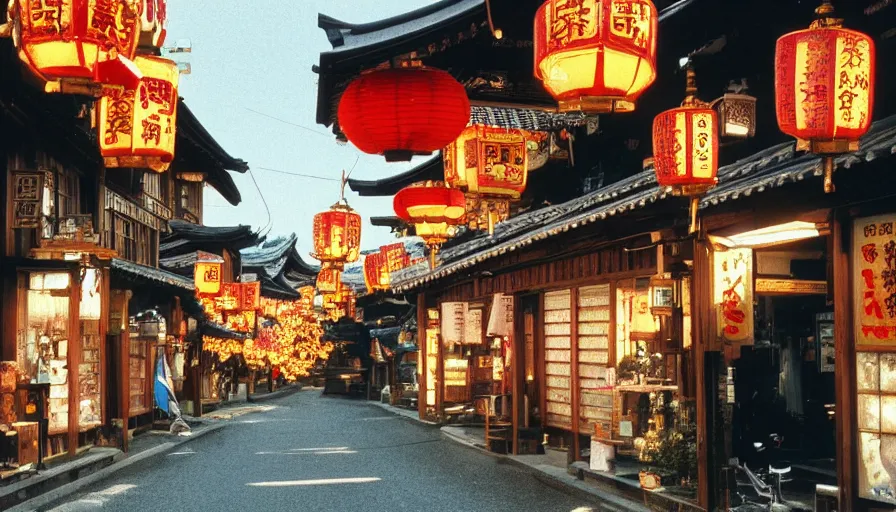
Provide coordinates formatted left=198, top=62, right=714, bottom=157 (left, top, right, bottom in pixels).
left=97, top=55, right=180, bottom=172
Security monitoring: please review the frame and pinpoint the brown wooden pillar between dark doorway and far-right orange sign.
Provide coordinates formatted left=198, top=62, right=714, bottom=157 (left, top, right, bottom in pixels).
left=829, top=212, right=857, bottom=512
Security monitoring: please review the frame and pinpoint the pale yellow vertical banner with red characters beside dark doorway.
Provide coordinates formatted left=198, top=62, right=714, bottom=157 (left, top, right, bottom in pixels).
left=713, top=249, right=754, bottom=345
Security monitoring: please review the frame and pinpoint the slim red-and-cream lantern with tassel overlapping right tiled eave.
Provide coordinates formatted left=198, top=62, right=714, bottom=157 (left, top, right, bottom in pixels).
left=653, top=66, right=719, bottom=233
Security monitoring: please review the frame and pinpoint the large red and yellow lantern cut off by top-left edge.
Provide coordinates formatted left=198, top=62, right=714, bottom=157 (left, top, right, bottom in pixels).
left=10, top=0, right=143, bottom=93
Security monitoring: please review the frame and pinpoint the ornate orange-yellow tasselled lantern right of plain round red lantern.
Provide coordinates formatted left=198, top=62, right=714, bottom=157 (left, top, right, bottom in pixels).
left=442, top=125, right=532, bottom=234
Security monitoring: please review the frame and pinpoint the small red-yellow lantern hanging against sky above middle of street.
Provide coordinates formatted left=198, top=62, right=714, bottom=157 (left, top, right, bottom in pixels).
left=312, top=202, right=361, bottom=268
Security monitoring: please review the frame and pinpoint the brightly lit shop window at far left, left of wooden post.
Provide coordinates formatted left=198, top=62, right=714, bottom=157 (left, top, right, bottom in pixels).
left=16, top=272, right=71, bottom=435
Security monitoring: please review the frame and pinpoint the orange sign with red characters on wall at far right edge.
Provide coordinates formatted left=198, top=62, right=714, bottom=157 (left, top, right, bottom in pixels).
left=853, top=215, right=896, bottom=346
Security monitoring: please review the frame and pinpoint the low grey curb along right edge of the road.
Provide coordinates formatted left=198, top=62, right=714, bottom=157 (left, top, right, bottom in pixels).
left=441, top=430, right=650, bottom=512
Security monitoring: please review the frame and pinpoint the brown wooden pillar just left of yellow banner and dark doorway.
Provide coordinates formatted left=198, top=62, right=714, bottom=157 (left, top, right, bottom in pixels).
left=691, top=241, right=715, bottom=510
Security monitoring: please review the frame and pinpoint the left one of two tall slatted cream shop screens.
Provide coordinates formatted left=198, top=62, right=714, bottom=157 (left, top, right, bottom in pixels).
left=544, top=290, right=572, bottom=430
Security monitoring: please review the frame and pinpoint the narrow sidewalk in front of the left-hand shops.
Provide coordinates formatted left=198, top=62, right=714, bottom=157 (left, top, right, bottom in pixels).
left=0, top=418, right=227, bottom=512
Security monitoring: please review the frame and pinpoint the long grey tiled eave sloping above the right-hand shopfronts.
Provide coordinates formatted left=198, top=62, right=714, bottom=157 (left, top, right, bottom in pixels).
left=392, top=116, right=896, bottom=292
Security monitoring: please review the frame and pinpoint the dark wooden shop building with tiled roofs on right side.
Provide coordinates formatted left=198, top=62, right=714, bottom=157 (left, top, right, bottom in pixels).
left=317, top=0, right=896, bottom=511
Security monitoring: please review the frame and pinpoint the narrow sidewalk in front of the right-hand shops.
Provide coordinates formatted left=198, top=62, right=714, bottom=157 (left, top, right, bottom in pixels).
left=370, top=402, right=652, bottom=512
